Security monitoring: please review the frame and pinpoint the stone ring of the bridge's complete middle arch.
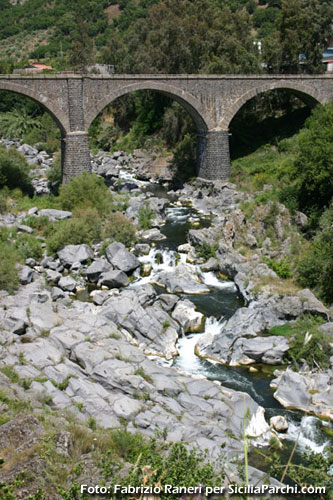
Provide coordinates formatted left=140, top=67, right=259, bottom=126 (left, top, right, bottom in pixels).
left=85, top=80, right=215, bottom=134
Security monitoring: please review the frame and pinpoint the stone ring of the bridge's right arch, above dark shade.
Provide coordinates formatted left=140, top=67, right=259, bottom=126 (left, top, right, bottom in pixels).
left=219, top=80, right=326, bottom=130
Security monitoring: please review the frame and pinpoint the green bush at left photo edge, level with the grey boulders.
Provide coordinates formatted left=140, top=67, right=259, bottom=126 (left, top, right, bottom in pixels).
left=0, top=242, right=20, bottom=293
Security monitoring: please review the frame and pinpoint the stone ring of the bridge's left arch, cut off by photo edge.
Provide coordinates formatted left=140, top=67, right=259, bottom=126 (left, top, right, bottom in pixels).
left=0, top=80, right=70, bottom=136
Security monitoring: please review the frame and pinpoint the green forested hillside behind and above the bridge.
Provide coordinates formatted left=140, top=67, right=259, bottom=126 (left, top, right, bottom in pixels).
left=0, top=0, right=332, bottom=73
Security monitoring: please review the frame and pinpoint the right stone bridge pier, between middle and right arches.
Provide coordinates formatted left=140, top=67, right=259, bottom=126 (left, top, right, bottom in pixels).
left=197, top=129, right=230, bottom=180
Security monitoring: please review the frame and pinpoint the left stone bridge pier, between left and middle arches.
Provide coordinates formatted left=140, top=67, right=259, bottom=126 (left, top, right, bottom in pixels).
left=61, top=131, right=91, bottom=183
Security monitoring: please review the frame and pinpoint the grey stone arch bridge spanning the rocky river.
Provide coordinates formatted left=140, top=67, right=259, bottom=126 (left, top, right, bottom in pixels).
left=0, top=73, right=333, bottom=182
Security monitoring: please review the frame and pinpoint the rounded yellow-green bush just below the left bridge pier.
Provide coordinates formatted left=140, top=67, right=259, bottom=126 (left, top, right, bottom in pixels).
left=59, top=172, right=114, bottom=216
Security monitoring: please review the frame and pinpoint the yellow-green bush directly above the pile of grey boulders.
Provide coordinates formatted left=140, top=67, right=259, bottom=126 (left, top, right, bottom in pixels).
left=46, top=208, right=102, bottom=254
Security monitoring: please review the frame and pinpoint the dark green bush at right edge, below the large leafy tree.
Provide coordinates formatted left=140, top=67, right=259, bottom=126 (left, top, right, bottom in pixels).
left=297, top=205, right=333, bottom=304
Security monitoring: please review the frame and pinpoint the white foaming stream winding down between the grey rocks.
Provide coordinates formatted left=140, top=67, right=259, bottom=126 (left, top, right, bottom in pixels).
left=131, top=192, right=333, bottom=472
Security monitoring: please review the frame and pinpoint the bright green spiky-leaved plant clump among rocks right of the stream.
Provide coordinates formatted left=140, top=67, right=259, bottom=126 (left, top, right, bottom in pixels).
left=269, top=315, right=333, bottom=370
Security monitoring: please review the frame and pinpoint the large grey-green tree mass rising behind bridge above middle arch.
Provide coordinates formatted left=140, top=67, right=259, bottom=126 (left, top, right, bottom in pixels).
left=103, top=0, right=261, bottom=73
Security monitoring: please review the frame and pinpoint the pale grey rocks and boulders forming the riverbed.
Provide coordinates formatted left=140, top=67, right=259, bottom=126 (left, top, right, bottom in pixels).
left=0, top=144, right=333, bottom=492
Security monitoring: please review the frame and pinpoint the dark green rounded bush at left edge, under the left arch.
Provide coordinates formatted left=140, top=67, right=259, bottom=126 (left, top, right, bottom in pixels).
left=0, top=147, right=33, bottom=195
